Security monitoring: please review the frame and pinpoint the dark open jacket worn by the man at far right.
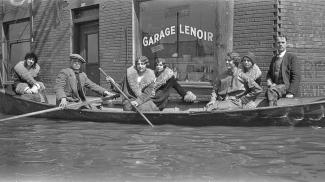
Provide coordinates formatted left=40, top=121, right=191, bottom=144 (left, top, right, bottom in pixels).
left=266, top=52, right=301, bottom=95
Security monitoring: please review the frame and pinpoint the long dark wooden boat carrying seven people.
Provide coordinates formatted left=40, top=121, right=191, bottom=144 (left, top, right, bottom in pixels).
left=0, top=91, right=325, bottom=126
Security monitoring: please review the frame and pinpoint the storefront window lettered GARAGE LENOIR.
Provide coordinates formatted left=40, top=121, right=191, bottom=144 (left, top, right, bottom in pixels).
left=139, top=0, right=216, bottom=82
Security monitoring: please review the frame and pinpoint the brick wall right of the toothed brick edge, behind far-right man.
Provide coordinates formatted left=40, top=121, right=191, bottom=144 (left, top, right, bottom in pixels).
left=278, top=0, right=325, bottom=96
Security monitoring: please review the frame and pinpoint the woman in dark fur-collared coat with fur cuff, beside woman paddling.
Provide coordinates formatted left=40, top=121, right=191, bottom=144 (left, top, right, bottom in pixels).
left=152, top=58, right=196, bottom=110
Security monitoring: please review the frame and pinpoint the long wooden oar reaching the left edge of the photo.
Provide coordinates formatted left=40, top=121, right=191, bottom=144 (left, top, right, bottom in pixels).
left=0, top=95, right=115, bottom=122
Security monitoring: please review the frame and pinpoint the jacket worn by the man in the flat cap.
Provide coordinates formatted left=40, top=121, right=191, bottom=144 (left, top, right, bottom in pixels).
left=54, top=68, right=106, bottom=102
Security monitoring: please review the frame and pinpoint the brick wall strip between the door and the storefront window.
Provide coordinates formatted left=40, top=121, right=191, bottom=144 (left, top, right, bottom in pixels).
left=99, top=0, right=132, bottom=87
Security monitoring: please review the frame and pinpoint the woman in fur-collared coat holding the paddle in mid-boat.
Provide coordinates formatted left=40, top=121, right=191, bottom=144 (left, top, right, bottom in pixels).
left=106, top=56, right=159, bottom=111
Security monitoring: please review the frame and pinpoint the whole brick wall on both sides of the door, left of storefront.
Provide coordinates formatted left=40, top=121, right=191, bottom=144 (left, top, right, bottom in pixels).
left=0, top=0, right=132, bottom=93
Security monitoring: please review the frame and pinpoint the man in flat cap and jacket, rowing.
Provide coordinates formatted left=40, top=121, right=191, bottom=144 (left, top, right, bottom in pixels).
left=54, top=54, right=113, bottom=107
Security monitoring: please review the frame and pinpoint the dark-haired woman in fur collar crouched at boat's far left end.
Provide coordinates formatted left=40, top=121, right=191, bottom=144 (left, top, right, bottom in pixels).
left=13, top=52, right=45, bottom=101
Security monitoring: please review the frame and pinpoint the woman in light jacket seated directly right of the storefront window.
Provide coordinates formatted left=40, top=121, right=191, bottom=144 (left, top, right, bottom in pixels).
left=206, top=52, right=262, bottom=111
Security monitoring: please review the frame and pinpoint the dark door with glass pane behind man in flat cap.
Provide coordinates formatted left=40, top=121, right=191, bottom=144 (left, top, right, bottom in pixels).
left=79, top=21, right=100, bottom=95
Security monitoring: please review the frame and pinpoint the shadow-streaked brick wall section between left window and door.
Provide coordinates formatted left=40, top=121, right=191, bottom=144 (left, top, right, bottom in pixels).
left=33, top=0, right=71, bottom=92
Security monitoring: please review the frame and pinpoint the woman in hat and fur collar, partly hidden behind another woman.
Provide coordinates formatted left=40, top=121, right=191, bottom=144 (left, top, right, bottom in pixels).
left=241, top=52, right=262, bottom=85
